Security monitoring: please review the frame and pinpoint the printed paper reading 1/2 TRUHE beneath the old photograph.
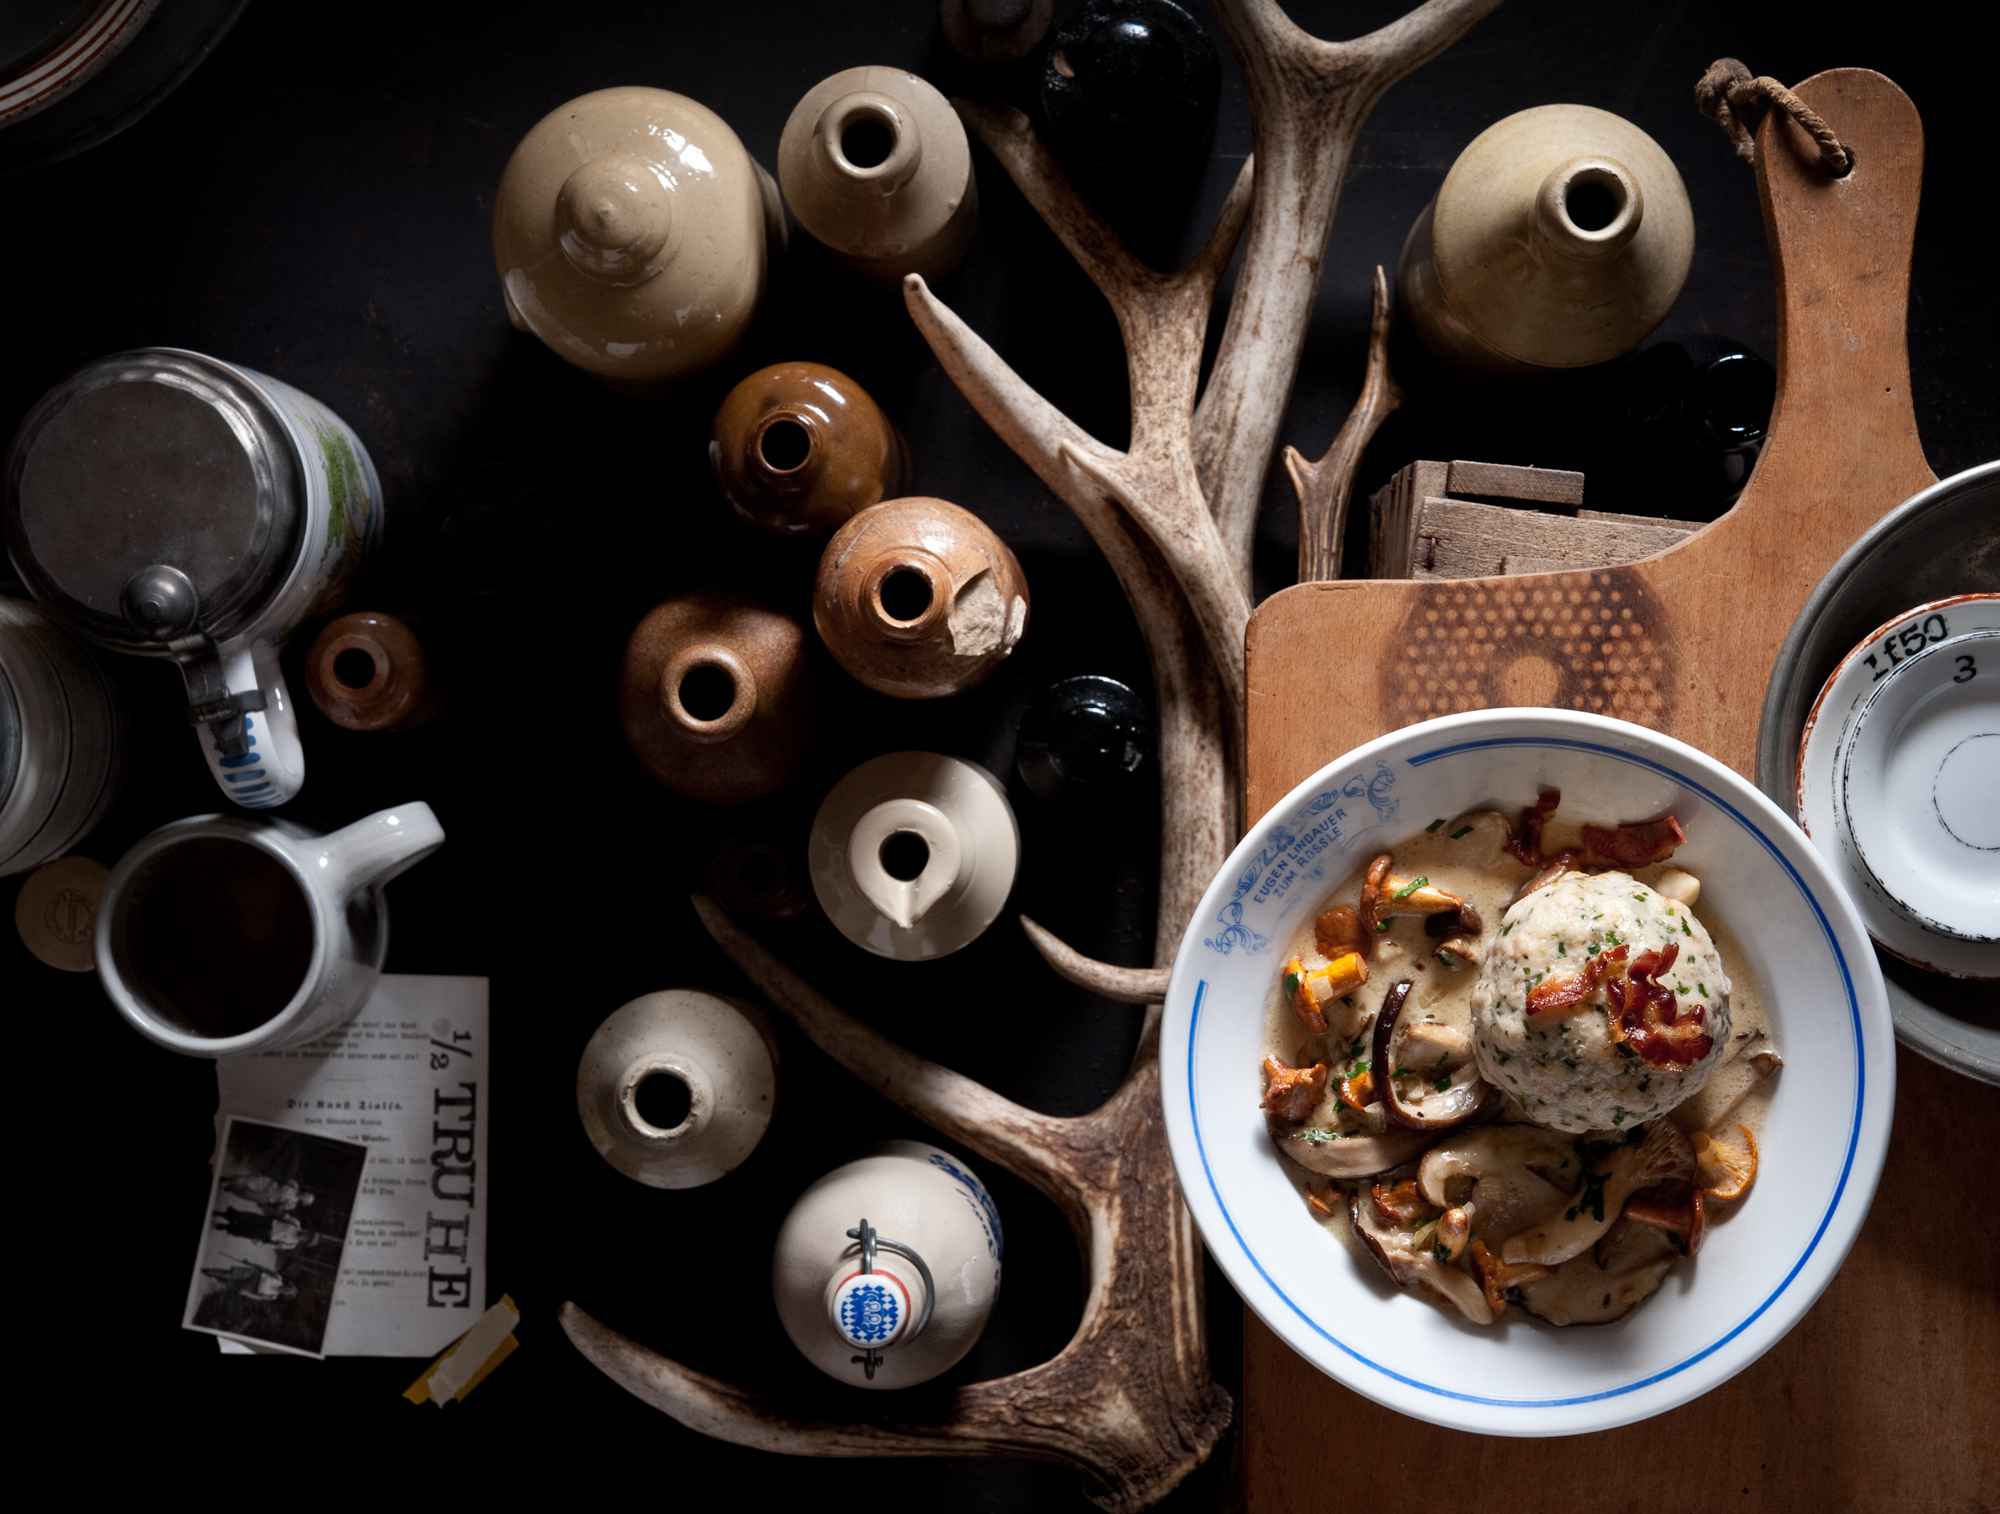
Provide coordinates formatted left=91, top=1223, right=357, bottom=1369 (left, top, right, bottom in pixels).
left=216, top=976, right=490, bottom=1356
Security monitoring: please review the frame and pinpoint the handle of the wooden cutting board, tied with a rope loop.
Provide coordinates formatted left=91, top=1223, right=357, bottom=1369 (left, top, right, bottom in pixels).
left=1736, top=68, right=1934, bottom=520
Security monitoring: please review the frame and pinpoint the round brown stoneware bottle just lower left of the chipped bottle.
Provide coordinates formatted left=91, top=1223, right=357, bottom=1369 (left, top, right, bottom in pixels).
left=618, top=594, right=812, bottom=804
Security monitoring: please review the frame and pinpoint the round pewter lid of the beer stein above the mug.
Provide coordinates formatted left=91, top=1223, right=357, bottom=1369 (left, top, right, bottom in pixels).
left=0, top=348, right=306, bottom=652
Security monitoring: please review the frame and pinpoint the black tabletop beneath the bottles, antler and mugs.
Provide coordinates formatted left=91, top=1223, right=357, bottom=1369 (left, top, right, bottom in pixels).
left=0, top=0, right=2000, bottom=1510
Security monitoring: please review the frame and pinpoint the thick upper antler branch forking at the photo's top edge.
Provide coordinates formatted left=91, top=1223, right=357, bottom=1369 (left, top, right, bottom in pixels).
left=1194, top=0, right=1500, bottom=582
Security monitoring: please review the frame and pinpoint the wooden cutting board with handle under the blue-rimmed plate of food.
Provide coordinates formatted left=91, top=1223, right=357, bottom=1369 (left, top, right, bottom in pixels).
left=1242, top=68, right=2000, bottom=1514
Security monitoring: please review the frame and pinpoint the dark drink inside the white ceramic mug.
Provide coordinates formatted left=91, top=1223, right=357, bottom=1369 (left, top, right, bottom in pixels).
left=112, top=836, right=312, bottom=1038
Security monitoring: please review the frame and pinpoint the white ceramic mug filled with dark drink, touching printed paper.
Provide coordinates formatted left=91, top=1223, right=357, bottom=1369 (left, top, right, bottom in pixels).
left=96, top=804, right=444, bottom=1056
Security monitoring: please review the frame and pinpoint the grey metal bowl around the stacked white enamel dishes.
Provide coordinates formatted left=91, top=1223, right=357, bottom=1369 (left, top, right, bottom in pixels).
left=1756, top=462, right=2000, bottom=1084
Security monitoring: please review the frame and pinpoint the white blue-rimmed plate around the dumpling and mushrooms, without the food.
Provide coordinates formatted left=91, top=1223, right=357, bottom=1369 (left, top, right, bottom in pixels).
left=1160, top=710, right=1896, bottom=1436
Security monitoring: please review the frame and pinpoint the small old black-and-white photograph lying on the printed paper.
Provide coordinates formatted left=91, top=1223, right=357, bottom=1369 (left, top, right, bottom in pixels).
left=182, top=1116, right=368, bottom=1356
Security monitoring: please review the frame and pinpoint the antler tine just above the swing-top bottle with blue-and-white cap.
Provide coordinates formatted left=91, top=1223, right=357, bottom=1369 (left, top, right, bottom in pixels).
left=694, top=896, right=1086, bottom=1214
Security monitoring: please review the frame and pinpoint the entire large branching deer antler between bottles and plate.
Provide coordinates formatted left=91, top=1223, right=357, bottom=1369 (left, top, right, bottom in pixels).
left=562, top=0, right=1500, bottom=1510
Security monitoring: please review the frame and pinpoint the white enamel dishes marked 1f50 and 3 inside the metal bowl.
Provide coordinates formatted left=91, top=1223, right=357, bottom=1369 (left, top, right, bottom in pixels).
left=1798, top=594, right=2000, bottom=978
